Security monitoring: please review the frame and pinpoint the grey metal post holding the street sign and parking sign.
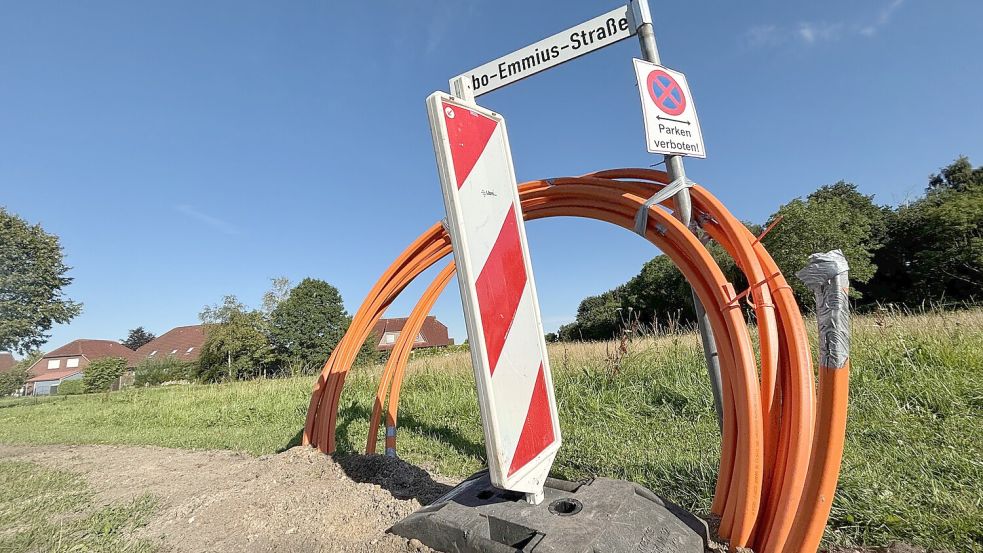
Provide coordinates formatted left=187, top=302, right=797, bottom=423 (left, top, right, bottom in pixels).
left=629, top=0, right=724, bottom=430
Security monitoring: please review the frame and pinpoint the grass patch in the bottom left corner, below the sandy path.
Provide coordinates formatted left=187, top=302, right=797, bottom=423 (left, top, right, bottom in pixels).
left=0, top=460, right=157, bottom=553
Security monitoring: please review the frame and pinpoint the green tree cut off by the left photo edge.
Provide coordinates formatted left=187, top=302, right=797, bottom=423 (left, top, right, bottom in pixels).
left=0, top=207, right=82, bottom=353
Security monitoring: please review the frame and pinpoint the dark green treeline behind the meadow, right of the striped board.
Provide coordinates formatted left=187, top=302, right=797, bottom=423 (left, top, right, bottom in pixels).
left=549, top=157, right=983, bottom=340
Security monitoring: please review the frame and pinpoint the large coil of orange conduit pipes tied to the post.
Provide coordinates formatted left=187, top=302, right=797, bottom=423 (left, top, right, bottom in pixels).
left=304, top=169, right=845, bottom=551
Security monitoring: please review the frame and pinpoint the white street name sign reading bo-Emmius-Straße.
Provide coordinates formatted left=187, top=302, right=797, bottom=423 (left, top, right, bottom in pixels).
left=451, top=4, right=636, bottom=97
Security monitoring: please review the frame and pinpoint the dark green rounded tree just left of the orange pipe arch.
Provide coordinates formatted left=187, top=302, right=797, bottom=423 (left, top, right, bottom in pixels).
left=270, top=278, right=351, bottom=372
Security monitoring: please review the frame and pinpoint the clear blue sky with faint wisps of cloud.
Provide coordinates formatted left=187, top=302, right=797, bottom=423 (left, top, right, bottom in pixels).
left=0, top=0, right=983, bottom=349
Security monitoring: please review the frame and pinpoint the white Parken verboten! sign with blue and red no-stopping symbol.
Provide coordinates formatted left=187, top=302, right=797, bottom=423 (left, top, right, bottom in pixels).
left=635, top=59, right=707, bottom=158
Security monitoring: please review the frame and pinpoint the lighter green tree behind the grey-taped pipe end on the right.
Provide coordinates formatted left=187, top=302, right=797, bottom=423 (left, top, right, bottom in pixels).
left=763, top=181, right=886, bottom=306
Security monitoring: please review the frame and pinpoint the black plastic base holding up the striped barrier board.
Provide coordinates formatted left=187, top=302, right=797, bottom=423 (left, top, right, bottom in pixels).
left=389, top=471, right=709, bottom=553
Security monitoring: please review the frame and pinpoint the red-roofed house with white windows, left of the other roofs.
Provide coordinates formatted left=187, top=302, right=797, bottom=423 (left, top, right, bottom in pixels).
left=26, top=340, right=137, bottom=396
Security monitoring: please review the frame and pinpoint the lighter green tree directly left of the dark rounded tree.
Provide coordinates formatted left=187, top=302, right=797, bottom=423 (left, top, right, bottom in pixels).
left=196, top=296, right=277, bottom=382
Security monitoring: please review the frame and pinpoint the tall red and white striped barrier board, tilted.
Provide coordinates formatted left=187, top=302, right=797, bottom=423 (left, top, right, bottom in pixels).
left=427, top=92, right=560, bottom=499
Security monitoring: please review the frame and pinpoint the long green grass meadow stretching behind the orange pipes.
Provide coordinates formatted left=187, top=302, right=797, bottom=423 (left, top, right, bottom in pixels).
left=0, top=310, right=983, bottom=552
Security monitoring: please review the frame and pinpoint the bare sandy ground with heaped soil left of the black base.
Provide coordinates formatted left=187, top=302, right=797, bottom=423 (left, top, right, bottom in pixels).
left=0, top=445, right=450, bottom=553
